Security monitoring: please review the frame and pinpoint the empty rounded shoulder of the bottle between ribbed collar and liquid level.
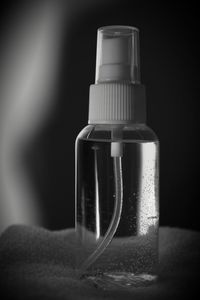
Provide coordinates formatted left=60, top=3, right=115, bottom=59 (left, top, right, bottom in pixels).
left=77, top=124, right=158, bottom=142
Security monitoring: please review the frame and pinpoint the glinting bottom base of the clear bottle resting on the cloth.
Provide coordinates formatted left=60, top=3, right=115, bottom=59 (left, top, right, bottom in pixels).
left=84, top=272, right=157, bottom=290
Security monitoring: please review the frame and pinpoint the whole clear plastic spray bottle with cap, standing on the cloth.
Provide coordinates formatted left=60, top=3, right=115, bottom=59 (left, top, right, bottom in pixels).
left=76, top=26, right=159, bottom=288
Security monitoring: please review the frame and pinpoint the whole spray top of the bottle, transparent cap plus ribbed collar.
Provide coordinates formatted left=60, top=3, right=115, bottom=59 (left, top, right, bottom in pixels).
left=89, top=26, right=146, bottom=124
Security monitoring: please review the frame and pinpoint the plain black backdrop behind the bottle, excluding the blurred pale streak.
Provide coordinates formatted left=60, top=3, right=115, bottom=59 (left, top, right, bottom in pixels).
left=1, top=0, right=200, bottom=229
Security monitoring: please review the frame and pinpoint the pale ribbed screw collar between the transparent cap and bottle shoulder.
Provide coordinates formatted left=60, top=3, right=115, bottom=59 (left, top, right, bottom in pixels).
left=88, top=82, right=146, bottom=124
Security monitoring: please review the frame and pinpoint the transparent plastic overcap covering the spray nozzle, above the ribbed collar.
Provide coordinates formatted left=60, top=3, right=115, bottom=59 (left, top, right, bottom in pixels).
left=95, top=26, right=140, bottom=84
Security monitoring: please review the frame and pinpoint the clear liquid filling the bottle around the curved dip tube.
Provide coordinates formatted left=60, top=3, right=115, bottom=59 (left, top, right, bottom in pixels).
left=76, top=139, right=159, bottom=288
